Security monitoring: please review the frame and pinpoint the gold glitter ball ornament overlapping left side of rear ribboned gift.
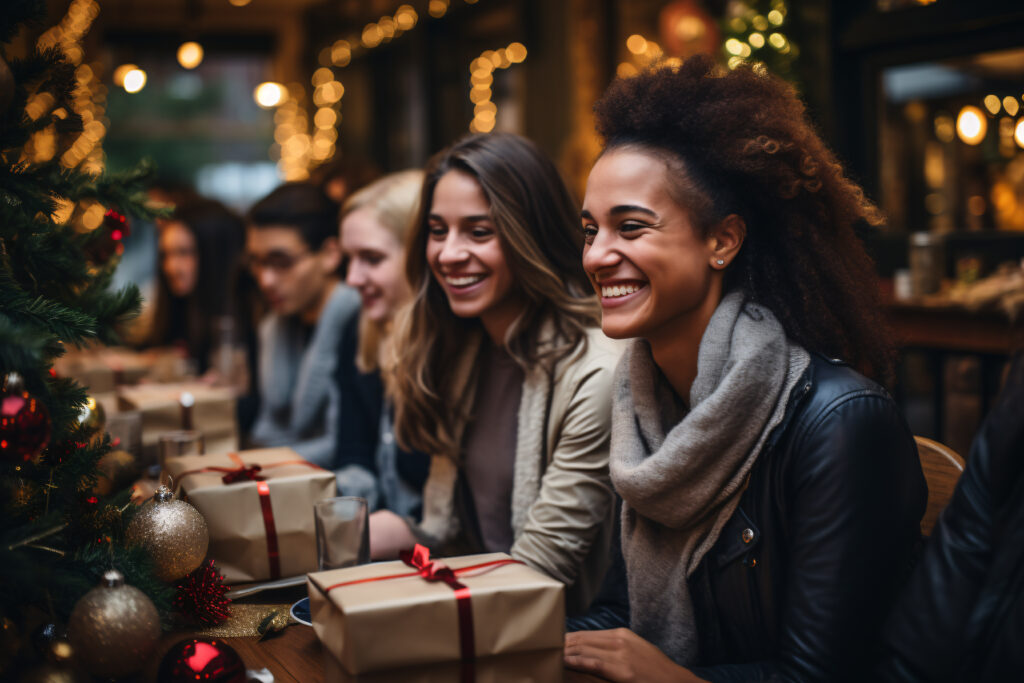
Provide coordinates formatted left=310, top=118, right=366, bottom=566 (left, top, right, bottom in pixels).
left=126, top=486, right=210, bottom=582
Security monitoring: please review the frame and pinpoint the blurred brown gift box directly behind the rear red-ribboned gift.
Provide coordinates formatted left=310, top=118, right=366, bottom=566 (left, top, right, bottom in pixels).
left=118, top=382, right=239, bottom=462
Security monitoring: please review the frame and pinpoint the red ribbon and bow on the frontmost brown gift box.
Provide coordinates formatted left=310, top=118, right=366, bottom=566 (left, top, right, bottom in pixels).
left=325, top=544, right=524, bottom=683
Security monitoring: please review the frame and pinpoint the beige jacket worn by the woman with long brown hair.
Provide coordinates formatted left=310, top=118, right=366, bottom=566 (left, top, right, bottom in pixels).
left=418, top=329, right=622, bottom=614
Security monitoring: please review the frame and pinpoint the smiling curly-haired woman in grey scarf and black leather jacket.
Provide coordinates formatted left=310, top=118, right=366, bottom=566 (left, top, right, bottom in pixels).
left=564, top=56, right=926, bottom=683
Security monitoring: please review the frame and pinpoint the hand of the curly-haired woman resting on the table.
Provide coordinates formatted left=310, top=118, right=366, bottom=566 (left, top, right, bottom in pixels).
left=563, top=629, right=702, bottom=683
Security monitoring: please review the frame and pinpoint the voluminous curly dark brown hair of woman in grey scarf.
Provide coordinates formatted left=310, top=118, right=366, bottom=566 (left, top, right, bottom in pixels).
left=595, top=55, right=894, bottom=379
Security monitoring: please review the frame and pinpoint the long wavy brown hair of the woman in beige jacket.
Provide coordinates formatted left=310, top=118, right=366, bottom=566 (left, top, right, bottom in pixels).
left=387, top=133, right=600, bottom=460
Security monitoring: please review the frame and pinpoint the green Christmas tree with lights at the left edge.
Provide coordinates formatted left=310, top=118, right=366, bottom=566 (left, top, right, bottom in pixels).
left=0, top=0, right=173, bottom=678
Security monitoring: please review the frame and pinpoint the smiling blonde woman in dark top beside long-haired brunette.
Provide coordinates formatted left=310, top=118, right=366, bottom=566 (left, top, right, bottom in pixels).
left=335, top=170, right=430, bottom=520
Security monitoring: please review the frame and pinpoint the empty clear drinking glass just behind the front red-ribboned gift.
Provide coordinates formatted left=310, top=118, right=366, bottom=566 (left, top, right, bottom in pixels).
left=313, top=496, right=370, bottom=571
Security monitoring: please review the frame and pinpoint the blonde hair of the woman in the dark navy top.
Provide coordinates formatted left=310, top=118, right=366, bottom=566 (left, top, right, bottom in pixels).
left=340, top=169, right=423, bottom=373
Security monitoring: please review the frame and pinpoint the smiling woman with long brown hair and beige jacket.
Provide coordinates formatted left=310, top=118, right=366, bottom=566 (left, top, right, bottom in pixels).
left=370, top=133, right=620, bottom=613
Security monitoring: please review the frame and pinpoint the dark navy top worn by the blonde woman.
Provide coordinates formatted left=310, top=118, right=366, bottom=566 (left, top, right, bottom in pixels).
left=334, top=315, right=430, bottom=519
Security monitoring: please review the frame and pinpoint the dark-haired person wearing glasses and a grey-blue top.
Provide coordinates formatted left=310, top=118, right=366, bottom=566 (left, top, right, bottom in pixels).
left=246, top=182, right=362, bottom=496
